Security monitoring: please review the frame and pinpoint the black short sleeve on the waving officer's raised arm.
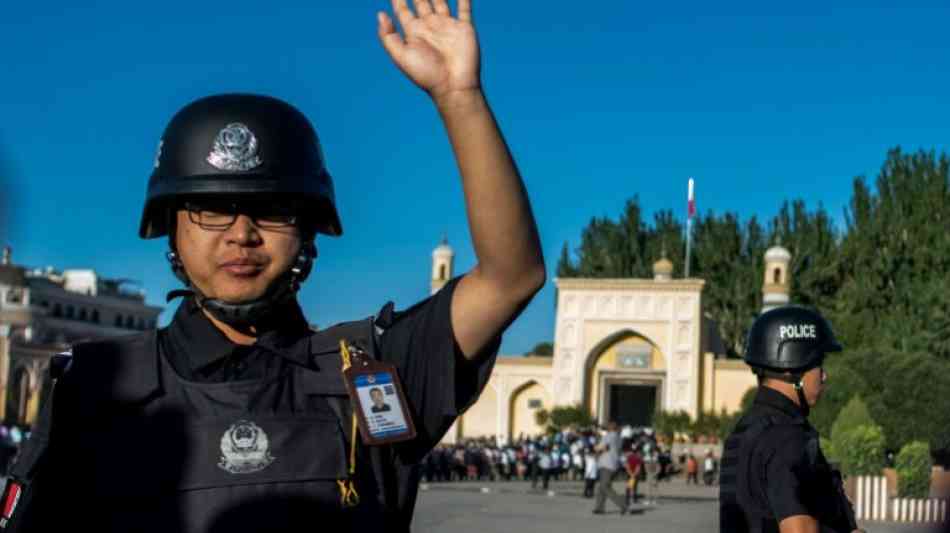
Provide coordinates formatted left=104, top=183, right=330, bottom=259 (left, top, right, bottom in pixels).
left=379, top=278, right=501, bottom=458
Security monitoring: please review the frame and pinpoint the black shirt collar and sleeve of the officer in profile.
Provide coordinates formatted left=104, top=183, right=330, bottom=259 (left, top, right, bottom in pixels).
left=748, top=387, right=817, bottom=522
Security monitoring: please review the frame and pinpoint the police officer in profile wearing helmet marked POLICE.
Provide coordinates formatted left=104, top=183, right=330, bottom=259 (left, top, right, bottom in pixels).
left=719, top=306, right=872, bottom=533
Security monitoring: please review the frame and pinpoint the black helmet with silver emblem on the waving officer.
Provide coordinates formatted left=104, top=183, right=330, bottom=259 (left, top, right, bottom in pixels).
left=139, top=94, right=343, bottom=239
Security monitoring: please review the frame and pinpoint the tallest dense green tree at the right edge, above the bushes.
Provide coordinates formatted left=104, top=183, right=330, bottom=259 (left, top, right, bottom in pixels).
left=834, top=148, right=950, bottom=358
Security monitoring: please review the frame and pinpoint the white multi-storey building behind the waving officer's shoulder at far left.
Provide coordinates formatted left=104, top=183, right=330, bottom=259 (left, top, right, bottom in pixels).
left=0, top=247, right=162, bottom=425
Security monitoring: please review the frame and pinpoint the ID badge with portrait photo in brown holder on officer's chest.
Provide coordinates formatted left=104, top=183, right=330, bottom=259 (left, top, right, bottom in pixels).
left=343, top=345, right=416, bottom=446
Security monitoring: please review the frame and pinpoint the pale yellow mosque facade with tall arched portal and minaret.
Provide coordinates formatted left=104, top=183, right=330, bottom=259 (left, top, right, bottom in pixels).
left=444, top=246, right=791, bottom=442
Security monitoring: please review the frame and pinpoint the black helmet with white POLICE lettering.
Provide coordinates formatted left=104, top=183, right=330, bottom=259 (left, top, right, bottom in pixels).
left=744, top=305, right=841, bottom=372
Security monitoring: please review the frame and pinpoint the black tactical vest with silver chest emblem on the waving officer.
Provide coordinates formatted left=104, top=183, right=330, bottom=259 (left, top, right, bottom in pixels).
left=8, top=319, right=418, bottom=533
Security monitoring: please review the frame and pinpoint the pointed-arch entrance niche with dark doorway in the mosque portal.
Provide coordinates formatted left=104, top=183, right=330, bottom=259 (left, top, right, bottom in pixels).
left=584, top=329, right=666, bottom=426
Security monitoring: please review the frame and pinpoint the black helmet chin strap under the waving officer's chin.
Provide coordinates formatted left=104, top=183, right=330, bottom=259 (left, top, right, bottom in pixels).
left=166, top=241, right=317, bottom=330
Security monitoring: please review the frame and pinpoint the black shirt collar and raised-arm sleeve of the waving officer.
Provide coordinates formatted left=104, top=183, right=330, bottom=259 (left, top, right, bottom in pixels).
left=160, top=278, right=501, bottom=459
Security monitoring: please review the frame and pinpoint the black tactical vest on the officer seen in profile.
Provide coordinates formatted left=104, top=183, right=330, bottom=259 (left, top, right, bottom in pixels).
left=719, top=415, right=856, bottom=533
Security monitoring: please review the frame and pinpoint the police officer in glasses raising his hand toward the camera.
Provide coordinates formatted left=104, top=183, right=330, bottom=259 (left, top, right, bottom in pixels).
left=0, top=0, right=545, bottom=533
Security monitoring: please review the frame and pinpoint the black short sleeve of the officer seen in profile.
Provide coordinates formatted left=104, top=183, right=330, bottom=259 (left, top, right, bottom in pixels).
left=763, top=431, right=815, bottom=522
